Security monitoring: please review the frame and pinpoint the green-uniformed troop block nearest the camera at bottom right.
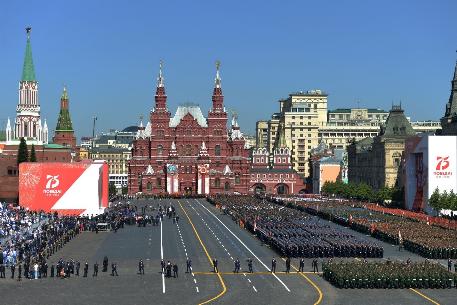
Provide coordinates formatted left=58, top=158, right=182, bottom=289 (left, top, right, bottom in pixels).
left=322, top=261, right=457, bottom=289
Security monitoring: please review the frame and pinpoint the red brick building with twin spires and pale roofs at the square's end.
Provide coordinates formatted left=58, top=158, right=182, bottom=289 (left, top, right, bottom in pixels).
left=128, top=64, right=305, bottom=195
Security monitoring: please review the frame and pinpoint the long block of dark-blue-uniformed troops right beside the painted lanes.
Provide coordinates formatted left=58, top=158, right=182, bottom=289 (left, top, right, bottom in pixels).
left=210, top=195, right=383, bottom=258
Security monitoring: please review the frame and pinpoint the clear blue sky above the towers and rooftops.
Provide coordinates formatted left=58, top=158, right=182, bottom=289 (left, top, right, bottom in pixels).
left=0, top=0, right=457, bottom=139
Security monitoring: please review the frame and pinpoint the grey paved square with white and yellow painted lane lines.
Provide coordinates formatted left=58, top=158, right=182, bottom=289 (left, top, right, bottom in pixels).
left=0, top=199, right=457, bottom=305
